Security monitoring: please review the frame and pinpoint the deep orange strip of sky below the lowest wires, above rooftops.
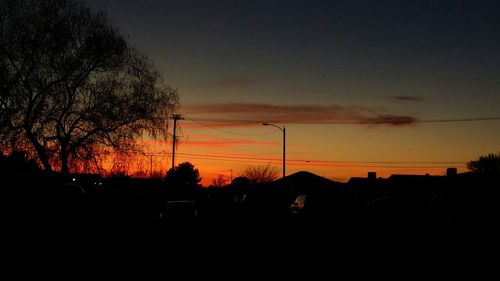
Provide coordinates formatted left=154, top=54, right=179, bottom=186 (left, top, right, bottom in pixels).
left=88, top=149, right=467, bottom=187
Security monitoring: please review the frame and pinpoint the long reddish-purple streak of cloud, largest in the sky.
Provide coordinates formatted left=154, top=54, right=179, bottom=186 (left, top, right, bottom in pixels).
left=182, top=103, right=418, bottom=127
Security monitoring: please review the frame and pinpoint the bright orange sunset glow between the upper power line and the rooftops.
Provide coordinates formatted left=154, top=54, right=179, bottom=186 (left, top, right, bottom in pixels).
left=80, top=121, right=479, bottom=186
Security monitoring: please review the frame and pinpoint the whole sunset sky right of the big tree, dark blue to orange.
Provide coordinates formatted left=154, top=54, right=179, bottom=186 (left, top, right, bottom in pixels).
left=85, top=0, right=500, bottom=185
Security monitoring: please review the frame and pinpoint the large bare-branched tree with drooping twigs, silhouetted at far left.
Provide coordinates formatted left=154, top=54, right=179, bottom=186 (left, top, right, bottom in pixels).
left=0, top=0, right=177, bottom=173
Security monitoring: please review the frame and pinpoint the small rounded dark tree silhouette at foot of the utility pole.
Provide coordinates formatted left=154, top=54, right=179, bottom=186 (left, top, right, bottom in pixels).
left=165, top=162, right=201, bottom=191
